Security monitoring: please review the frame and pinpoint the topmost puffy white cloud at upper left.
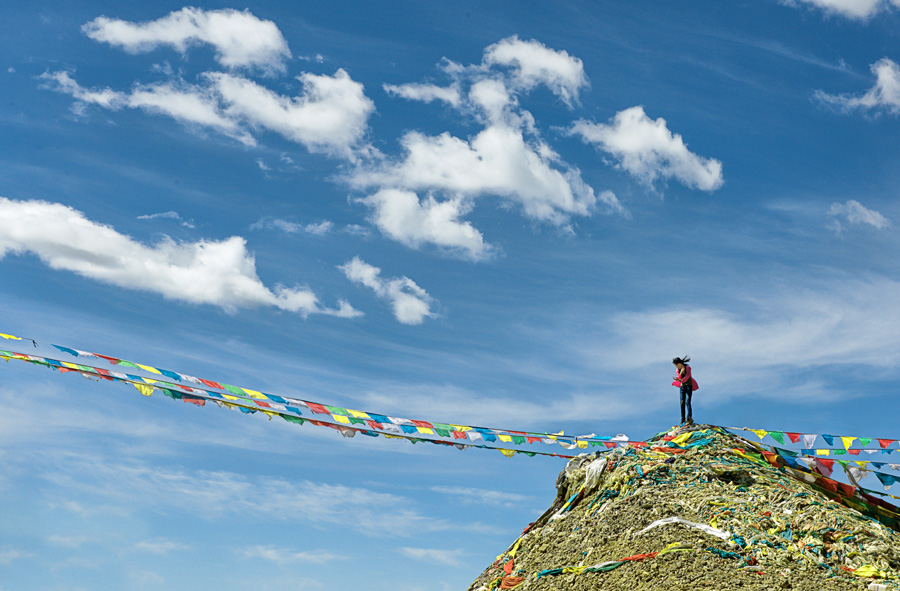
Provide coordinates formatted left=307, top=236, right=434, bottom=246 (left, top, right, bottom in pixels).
left=82, top=7, right=291, bottom=73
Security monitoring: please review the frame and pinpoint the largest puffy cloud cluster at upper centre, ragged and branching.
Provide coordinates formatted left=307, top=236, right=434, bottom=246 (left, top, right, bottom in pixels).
left=356, top=37, right=627, bottom=260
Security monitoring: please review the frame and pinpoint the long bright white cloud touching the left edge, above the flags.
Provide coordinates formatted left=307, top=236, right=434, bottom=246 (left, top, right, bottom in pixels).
left=0, top=197, right=360, bottom=317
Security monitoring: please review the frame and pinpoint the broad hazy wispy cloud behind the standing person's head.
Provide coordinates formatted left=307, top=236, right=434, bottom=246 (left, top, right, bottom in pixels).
left=588, top=277, right=900, bottom=399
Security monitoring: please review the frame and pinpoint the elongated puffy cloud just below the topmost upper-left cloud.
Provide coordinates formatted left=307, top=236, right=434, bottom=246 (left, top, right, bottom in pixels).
left=40, top=69, right=375, bottom=158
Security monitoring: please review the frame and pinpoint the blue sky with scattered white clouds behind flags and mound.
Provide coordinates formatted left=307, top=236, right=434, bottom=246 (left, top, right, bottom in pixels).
left=0, top=0, right=900, bottom=591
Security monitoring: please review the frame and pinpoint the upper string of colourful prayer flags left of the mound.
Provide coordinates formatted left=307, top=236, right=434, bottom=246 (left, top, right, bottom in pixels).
left=0, top=334, right=646, bottom=449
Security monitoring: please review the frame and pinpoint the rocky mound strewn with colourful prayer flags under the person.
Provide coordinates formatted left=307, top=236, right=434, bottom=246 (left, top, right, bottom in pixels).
left=469, top=425, right=900, bottom=591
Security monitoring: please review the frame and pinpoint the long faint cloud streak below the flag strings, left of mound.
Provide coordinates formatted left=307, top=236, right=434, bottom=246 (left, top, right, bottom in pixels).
left=31, top=450, right=472, bottom=537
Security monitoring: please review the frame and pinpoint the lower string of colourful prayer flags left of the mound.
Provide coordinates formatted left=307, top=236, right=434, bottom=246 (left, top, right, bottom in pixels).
left=0, top=350, right=632, bottom=459
